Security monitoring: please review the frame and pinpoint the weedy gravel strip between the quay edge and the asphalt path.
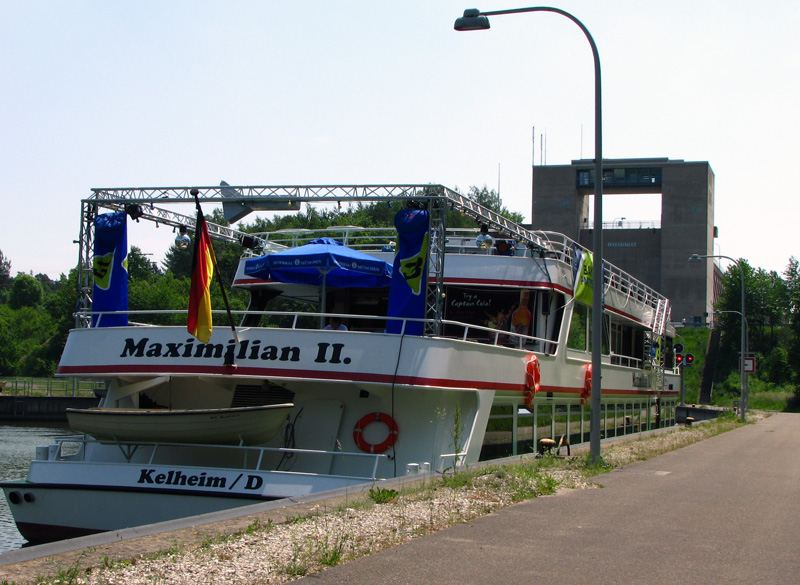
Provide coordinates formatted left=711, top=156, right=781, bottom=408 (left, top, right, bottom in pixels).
left=7, top=412, right=736, bottom=585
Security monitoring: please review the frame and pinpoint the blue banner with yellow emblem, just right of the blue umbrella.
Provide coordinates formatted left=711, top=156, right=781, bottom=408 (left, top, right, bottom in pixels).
left=386, top=209, right=430, bottom=335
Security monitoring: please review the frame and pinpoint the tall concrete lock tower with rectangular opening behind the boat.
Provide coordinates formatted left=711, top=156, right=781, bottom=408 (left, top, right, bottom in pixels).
left=532, top=158, right=720, bottom=326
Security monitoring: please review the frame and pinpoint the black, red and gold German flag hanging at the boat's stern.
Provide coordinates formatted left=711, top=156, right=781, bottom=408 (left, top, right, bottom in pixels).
left=186, top=205, right=217, bottom=343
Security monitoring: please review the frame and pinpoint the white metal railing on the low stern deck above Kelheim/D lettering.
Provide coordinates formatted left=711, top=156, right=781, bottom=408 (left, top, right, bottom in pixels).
left=47, top=435, right=388, bottom=481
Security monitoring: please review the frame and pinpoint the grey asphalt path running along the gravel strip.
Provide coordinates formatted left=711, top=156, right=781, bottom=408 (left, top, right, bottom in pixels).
left=295, top=414, right=800, bottom=585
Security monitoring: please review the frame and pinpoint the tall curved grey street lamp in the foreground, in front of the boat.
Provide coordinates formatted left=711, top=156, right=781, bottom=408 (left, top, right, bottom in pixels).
left=453, top=6, right=604, bottom=462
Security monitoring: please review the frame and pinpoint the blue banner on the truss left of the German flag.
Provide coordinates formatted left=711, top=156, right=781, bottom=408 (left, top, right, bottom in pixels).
left=92, top=211, right=128, bottom=327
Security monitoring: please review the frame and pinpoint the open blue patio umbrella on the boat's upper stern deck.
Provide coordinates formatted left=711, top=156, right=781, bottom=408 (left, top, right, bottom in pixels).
left=244, top=238, right=392, bottom=313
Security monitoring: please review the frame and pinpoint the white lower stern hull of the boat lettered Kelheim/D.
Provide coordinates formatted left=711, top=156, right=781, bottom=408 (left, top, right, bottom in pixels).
left=0, top=454, right=384, bottom=543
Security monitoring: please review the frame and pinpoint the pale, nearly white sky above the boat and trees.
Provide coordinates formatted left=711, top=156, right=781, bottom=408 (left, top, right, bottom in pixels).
left=0, top=0, right=800, bottom=278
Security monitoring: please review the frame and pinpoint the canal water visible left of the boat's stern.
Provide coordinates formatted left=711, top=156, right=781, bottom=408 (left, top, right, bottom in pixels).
left=0, top=423, right=69, bottom=552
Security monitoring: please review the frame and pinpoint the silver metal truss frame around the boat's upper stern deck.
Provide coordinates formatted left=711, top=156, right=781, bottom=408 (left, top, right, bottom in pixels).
left=79, top=184, right=669, bottom=344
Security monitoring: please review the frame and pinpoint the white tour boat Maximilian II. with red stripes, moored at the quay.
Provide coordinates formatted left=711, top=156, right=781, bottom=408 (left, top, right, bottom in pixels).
left=1, top=184, right=678, bottom=542
